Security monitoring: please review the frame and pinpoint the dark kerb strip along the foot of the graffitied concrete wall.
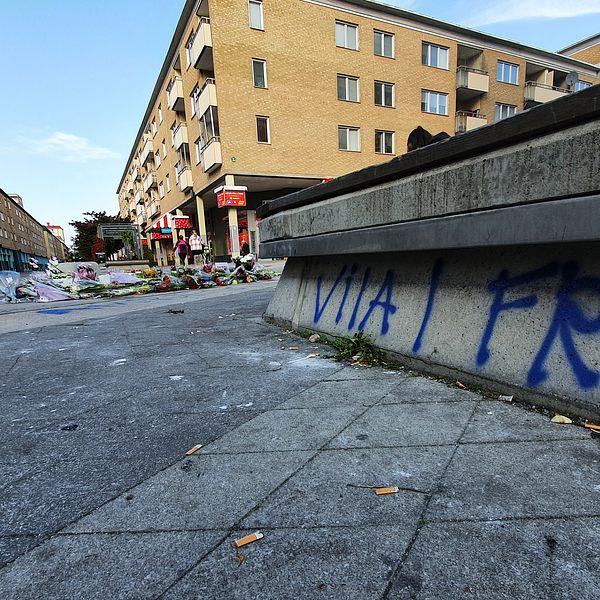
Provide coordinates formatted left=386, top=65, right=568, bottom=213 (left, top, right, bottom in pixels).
left=263, top=313, right=600, bottom=421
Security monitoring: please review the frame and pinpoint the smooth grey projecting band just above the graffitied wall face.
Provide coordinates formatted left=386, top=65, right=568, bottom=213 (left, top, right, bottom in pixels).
left=261, top=195, right=600, bottom=257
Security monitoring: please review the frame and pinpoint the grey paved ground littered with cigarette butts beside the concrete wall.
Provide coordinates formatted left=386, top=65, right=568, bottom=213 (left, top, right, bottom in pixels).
left=0, top=288, right=600, bottom=600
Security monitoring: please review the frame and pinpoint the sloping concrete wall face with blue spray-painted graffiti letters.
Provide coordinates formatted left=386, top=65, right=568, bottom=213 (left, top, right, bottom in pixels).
left=266, top=244, right=600, bottom=418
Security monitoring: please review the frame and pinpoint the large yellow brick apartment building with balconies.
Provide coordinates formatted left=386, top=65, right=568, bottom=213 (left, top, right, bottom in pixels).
left=117, top=0, right=600, bottom=264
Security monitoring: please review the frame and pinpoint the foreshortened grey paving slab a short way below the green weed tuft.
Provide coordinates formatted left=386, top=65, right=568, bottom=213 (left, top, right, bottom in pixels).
left=278, top=379, right=396, bottom=408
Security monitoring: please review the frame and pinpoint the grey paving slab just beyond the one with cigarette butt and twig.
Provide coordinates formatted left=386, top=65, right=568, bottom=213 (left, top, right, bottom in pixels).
left=328, top=402, right=476, bottom=448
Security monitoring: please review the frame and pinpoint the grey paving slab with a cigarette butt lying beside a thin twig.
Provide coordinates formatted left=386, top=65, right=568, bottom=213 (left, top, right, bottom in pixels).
left=243, top=447, right=452, bottom=528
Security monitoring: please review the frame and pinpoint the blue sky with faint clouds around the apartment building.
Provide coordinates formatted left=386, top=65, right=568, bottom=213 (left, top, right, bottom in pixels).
left=0, top=0, right=600, bottom=245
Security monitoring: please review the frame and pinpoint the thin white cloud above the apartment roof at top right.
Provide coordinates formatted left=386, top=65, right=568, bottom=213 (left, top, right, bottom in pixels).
left=465, top=0, right=600, bottom=26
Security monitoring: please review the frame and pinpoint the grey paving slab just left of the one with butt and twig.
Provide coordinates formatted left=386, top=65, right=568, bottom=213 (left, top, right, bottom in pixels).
left=69, top=452, right=312, bottom=532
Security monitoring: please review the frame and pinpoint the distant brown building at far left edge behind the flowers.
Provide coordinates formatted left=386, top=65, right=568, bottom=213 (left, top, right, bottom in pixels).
left=0, top=189, right=69, bottom=271
